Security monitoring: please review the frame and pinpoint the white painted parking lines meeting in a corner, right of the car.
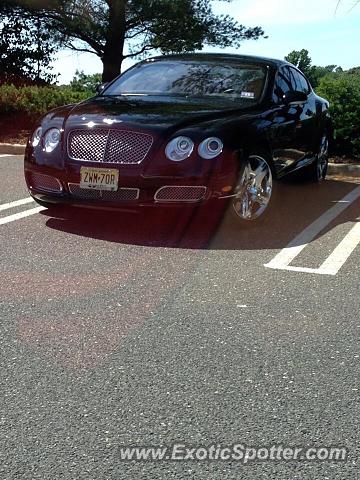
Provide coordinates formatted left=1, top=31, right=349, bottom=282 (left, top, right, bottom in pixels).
left=264, top=187, right=360, bottom=275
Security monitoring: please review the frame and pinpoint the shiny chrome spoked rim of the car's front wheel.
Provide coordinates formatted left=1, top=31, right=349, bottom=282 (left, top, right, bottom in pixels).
left=232, top=155, right=273, bottom=221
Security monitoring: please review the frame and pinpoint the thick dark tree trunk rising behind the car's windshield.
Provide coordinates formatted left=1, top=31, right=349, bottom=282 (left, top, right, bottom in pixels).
left=102, top=0, right=126, bottom=82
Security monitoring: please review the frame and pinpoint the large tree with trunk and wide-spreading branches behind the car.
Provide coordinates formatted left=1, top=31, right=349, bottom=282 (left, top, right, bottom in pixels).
left=3, top=0, right=264, bottom=81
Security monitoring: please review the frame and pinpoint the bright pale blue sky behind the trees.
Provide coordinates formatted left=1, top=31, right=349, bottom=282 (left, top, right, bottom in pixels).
left=54, top=0, right=360, bottom=84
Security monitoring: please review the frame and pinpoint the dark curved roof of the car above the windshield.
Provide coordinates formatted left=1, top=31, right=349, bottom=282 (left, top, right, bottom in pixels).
left=145, top=53, right=290, bottom=67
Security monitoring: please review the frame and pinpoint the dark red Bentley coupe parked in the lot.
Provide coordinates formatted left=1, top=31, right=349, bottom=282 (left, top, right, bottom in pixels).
left=25, top=54, right=331, bottom=222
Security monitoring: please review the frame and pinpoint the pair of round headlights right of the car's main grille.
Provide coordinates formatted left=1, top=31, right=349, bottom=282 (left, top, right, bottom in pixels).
left=165, top=137, right=224, bottom=162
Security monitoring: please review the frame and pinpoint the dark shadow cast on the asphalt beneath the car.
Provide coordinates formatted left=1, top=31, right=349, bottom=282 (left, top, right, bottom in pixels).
left=42, top=180, right=357, bottom=250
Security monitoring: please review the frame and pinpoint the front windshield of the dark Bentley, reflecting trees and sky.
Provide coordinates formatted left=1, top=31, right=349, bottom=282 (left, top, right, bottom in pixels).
left=104, top=61, right=266, bottom=101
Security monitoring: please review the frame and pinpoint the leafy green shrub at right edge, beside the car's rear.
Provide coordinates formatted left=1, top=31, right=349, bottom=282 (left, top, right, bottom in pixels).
left=317, top=73, right=360, bottom=155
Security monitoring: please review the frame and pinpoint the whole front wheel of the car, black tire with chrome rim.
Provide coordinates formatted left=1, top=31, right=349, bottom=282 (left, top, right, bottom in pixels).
left=229, top=150, right=277, bottom=227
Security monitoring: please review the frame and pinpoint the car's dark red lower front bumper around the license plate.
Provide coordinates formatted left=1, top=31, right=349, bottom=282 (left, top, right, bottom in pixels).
left=25, top=160, right=235, bottom=209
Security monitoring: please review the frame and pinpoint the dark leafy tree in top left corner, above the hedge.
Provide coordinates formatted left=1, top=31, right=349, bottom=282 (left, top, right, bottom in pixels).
left=0, top=6, right=56, bottom=83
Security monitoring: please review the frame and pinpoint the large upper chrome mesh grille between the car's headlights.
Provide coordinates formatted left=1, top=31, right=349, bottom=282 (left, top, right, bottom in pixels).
left=68, top=128, right=153, bottom=164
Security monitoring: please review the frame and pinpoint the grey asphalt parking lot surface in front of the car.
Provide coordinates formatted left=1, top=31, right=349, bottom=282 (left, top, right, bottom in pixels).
left=0, top=156, right=360, bottom=480
